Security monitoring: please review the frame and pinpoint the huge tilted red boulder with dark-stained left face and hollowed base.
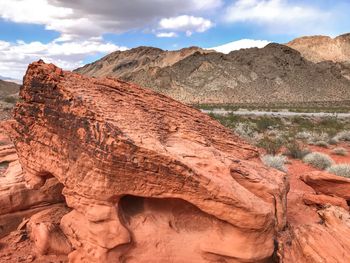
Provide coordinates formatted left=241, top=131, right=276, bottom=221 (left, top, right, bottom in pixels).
left=6, top=61, right=288, bottom=262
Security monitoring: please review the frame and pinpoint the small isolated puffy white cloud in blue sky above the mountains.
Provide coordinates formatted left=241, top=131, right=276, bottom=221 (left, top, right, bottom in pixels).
left=159, top=15, right=214, bottom=36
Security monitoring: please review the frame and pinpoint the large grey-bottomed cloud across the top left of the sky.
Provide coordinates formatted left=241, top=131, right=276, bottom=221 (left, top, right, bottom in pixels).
left=0, top=0, right=222, bottom=40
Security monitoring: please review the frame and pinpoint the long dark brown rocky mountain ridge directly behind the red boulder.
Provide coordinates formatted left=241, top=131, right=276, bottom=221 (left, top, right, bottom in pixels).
left=76, top=43, right=350, bottom=105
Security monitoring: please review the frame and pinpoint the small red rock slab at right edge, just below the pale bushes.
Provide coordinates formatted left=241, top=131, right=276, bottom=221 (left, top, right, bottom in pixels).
left=301, top=172, right=350, bottom=200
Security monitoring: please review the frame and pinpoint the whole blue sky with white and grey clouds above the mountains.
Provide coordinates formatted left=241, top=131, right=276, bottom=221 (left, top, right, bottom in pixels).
left=0, top=0, right=350, bottom=79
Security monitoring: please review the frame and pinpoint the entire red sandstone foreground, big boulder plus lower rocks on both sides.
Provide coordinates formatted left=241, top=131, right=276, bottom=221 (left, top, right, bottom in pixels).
left=0, top=61, right=350, bottom=263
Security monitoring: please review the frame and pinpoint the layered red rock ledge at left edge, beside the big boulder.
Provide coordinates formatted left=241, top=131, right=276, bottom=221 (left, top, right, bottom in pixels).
left=0, top=129, right=64, bottom=238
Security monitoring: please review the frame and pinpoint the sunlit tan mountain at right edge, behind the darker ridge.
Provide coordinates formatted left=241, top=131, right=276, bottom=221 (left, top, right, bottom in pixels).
left=286, top=33, right=350, bottom=63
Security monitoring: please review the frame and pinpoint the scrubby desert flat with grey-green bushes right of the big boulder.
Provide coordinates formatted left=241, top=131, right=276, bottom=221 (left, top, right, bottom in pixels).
left=210, top=110, right=350, bottom=177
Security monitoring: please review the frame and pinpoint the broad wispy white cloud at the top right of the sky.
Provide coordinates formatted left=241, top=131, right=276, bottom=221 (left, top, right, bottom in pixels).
left=224, top=0, right=330, bottom=35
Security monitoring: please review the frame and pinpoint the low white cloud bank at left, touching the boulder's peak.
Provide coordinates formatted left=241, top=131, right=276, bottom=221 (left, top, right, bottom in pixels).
left=0, top=39, right=127, bottom=79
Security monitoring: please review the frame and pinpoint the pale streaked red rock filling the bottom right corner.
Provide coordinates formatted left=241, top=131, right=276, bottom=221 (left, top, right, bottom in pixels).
left=279, top=206, right=350, bottom=263
